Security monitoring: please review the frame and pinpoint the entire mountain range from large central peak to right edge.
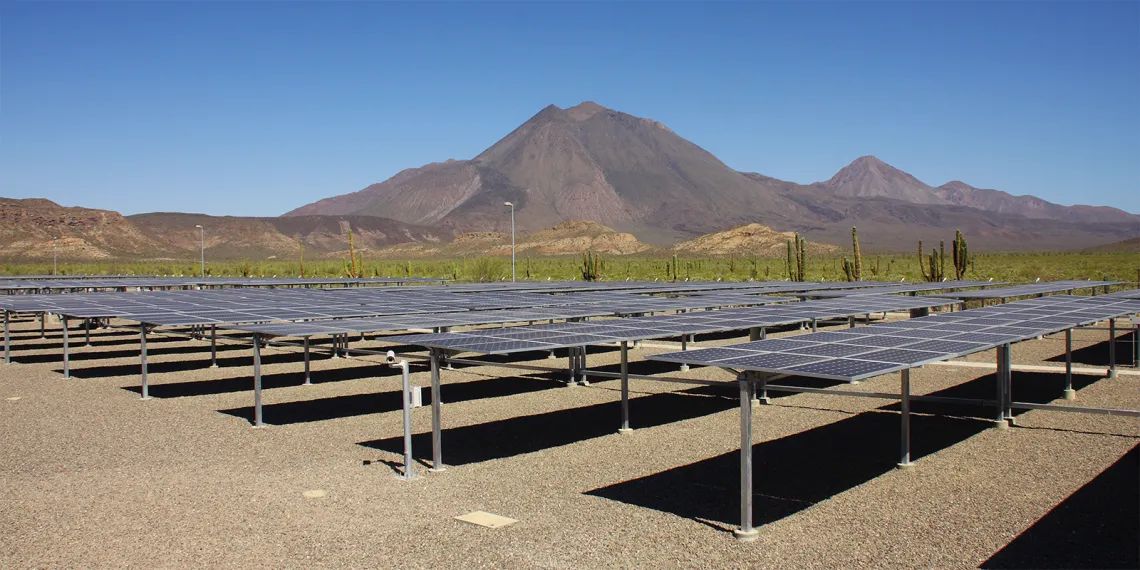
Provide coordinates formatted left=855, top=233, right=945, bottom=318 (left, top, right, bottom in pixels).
left=285, top=101, right=1140, bottom=250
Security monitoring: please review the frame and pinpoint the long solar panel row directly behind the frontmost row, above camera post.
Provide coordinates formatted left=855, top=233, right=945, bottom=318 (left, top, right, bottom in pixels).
left=384, top=295, right=956, bottom=355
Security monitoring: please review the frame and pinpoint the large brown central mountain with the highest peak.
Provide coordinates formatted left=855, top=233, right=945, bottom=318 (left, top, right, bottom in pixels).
left=285, top=101, right=803, bottom=235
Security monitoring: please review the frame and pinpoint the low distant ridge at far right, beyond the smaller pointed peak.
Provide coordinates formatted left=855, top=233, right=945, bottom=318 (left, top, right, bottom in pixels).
left=934, top=180, right=1140, bottom=223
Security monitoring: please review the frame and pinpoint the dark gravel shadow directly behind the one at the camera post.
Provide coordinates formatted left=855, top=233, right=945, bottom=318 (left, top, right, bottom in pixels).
left=217, top=377, right=561, bottom=424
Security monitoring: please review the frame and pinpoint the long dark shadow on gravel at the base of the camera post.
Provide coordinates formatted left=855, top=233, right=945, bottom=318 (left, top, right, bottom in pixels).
left=359, top=385, right=736, bottom=465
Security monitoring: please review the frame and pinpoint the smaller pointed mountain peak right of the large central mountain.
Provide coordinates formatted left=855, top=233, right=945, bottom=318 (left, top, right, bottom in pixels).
left=822, top=156, right=947, bottom=204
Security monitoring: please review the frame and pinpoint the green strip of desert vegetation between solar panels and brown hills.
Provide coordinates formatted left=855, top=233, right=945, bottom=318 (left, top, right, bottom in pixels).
left=0, top=251, right=1140, bottom=283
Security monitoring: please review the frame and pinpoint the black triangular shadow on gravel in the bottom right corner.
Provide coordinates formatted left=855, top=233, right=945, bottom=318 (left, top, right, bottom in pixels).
left=980, top=446, right=1140, bottom=569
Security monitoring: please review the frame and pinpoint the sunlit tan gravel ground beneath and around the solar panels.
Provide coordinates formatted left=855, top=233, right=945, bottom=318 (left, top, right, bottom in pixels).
left=0, top=314, right=1140, bottom=568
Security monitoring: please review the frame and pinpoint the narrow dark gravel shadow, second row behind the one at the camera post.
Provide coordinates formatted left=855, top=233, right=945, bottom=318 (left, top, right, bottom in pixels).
left=117, top=355, right=389, bottom=398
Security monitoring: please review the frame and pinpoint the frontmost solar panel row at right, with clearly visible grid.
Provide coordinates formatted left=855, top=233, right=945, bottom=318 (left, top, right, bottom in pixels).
left=648, top=295, right=1140, bottom=381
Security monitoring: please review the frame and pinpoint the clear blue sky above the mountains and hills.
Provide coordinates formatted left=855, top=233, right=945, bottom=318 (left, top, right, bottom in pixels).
left=0, top=1, right=1140, bottom=215
